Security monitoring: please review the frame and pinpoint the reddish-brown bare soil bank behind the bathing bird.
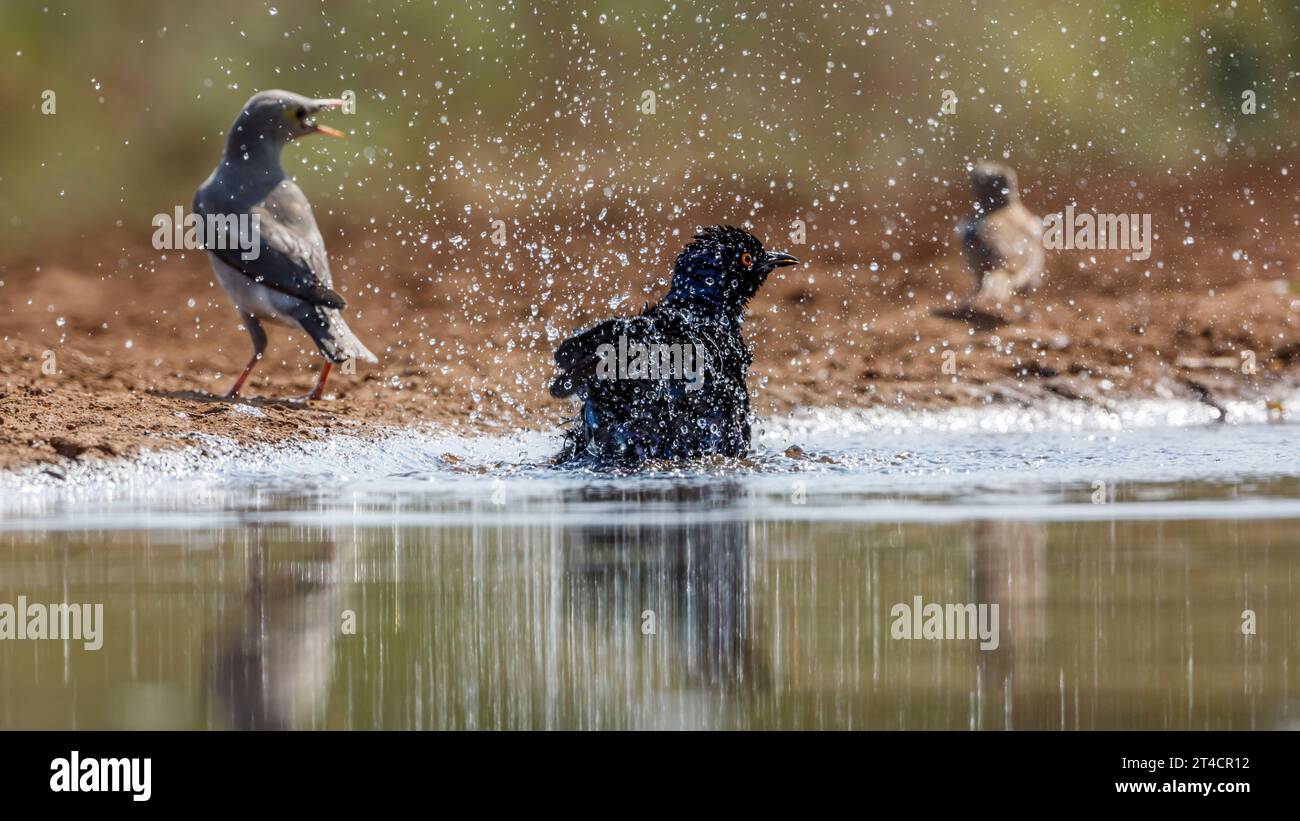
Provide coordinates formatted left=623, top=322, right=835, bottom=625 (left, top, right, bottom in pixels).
left=0, top=170, right=1300, bottom=468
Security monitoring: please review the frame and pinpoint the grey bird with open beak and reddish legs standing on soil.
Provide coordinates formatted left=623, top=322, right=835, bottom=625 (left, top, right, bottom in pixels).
left=194, top=91, right=378, bottom=400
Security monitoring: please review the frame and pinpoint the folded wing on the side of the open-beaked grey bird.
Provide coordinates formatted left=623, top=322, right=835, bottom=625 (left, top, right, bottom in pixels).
left=194, top=183, right=346, bottom=308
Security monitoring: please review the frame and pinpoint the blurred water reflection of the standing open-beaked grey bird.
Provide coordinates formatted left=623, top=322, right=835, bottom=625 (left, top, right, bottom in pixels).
left=208, top=534, right=354, bottom=730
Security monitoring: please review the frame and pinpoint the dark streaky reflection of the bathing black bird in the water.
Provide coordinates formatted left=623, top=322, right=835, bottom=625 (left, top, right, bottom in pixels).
left=563, top=483, right=764, bottom=725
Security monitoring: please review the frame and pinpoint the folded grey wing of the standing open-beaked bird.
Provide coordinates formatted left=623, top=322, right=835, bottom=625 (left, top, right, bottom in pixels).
left=194, top=191, right=346, bottom=308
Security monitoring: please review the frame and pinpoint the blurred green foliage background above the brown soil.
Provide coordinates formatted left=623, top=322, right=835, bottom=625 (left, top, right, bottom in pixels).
left=0, top=0, right=1300, bottom=251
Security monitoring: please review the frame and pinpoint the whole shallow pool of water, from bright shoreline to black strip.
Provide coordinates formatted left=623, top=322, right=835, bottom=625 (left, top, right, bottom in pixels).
left=0, top=403, right=1300, bottom=729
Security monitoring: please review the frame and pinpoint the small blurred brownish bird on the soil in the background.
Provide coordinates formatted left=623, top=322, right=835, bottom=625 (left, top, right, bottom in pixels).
left=957, top=162, right=1044, bottom=304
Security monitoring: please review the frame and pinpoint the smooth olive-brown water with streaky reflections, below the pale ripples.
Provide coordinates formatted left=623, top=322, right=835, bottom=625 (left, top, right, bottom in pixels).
left=0, top=479, right=1300, bottom=729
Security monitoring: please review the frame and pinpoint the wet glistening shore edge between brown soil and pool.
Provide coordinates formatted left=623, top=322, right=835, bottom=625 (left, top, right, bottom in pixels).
left=0, top=375, right=1300, bottom=490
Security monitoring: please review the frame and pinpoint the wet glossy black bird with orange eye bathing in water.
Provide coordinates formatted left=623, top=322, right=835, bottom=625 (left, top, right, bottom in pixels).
left=551, top=226, right=798, bottom=465
